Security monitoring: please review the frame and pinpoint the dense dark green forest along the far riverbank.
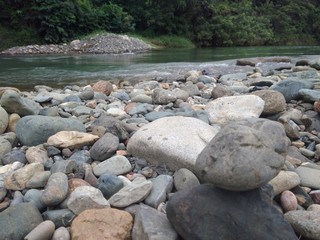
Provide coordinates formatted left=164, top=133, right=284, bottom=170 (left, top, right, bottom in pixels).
left=0, top=0, right=320, bottom=47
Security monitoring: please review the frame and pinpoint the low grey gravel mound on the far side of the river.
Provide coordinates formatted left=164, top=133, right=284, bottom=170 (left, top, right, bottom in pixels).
left=0, top=33, right=152, bottom=56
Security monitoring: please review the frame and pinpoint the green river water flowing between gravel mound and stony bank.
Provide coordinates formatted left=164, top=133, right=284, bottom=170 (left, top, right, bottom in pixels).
left=0, top=46, right=320, bottom=90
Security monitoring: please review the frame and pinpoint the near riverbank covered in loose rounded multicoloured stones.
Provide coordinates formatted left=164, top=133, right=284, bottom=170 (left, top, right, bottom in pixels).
left=0, top=57, right=320, bottom=240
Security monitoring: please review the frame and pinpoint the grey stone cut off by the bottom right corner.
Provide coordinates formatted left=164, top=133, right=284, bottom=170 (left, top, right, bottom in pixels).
left=284, top=210, right=320, bottom=239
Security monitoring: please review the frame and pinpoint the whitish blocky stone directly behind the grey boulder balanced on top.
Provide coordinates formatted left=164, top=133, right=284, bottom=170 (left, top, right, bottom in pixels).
left=205, top=95, right=265, bottom=124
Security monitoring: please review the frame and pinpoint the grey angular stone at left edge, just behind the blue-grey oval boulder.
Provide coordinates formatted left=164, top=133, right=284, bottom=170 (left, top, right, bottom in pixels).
left=0, top=90, right=41, bottom=117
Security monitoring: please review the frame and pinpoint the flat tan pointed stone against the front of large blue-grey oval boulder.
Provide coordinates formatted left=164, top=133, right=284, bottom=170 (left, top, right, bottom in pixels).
left=47, top=131, right=99, bottom=149
